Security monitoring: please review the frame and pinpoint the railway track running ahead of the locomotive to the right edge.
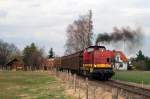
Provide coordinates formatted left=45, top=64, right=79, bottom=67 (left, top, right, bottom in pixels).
left=75, top=76, right=150, bottom=99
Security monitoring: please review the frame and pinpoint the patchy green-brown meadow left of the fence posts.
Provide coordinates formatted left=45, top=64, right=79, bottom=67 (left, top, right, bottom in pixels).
left=0, top=71, right=72, bottom=99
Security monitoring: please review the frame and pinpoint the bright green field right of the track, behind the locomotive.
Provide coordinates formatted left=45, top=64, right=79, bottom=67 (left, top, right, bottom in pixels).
left=112, top=71, right=150, bottom=85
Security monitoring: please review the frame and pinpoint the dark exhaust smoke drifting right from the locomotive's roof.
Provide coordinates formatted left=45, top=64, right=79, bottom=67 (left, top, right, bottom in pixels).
left=96, top=27, right=144, bottom=52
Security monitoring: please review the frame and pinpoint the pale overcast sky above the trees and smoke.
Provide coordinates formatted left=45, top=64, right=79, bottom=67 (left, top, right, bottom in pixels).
left=0, top=0, right=150, bottom=56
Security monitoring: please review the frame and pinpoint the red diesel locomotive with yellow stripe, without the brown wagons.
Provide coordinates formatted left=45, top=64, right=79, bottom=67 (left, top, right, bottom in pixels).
left=83, top=46, right=114, bottom=80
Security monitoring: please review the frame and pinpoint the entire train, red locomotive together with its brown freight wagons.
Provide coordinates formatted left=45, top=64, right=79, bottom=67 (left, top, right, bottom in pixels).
left=54, top=46, right=127, bottom=80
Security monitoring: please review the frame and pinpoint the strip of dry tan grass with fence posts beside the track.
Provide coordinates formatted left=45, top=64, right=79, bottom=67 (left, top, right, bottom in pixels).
left=49, top=70, right=141, bottom=99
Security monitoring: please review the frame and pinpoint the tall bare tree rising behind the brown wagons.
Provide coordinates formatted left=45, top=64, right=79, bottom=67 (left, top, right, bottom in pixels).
left=65, top=10, right=93, bottom=54
